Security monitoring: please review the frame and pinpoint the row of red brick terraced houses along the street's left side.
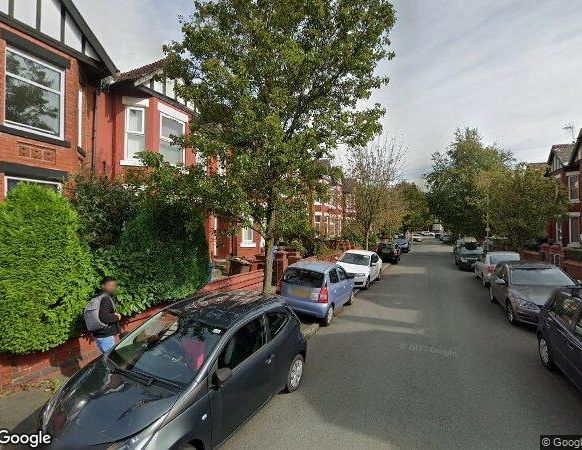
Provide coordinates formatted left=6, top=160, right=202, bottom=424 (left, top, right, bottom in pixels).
left=0, top=0, right=353, bottom=258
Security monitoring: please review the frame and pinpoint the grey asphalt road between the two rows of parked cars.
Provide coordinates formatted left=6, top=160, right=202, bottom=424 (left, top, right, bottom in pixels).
left=223, top=240, right=582, bottom=449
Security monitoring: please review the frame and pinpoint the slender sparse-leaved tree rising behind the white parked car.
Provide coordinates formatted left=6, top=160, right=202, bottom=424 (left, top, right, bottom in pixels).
left=349, top=138, right=404, bottom=249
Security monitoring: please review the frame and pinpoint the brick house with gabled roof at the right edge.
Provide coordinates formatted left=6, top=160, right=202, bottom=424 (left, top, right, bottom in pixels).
left=547, top=142, right=582, bottom=246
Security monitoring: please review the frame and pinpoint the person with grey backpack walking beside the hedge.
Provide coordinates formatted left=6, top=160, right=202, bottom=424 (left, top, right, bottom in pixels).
left=84, top=276, right=121, bottom=353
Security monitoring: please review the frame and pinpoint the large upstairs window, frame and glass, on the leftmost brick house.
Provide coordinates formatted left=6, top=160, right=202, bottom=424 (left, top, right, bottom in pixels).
left=4, top=48, right=65, bottom=139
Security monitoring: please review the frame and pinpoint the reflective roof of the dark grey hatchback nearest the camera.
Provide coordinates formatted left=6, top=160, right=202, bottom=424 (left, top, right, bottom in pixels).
left=167, top=291, right=284, bottom=329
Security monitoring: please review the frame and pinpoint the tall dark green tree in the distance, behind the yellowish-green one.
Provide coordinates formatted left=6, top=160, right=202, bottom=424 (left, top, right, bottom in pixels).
left=425, top=128, right=513, bottom=236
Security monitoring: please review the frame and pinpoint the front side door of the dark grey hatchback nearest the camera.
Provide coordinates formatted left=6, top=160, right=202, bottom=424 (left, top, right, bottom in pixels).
left=210, top=317, right=274, bottom=446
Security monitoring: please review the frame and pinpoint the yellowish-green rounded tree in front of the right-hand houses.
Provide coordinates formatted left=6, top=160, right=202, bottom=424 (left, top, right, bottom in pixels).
left=477, top=164, right=569, bottom=251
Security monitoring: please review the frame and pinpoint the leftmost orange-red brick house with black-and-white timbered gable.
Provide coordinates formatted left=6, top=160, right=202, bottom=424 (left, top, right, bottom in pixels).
left=0, top=0, right=117, bottom=200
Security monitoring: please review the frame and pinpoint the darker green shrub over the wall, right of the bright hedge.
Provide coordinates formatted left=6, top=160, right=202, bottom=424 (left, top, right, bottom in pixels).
left=95, top=204, right=208, bottom=315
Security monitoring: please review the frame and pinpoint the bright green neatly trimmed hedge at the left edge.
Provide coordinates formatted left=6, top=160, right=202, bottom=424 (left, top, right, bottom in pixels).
left=0, top=183, right=95, bottom=354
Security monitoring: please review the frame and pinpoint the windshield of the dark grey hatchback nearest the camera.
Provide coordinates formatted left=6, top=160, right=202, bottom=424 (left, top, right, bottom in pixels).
left=109, top=310, right=224, bottom=385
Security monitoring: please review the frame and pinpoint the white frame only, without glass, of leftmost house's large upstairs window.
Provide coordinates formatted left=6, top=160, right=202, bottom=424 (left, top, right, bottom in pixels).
left=3, top=45, right=65, bottom=140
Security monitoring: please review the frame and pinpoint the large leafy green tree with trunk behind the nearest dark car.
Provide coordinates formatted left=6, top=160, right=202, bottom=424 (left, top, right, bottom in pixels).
left=165, top=0, right=395, bottom=292
